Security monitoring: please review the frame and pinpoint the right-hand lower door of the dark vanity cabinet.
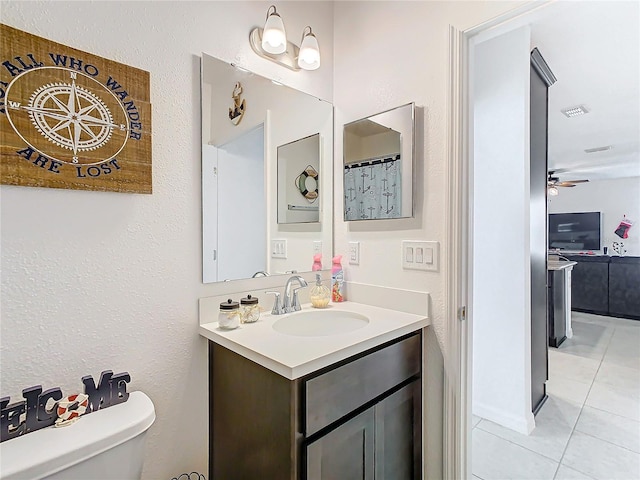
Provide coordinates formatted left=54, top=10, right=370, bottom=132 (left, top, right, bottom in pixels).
left=375, top=381, right=422, bottom=480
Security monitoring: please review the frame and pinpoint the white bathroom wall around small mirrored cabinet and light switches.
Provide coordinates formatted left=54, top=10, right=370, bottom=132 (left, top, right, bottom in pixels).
left=334, top=1, right=524, bottom=479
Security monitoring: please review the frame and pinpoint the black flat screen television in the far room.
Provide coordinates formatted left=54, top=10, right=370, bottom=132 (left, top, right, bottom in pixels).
left=549, top=212, right=600, bottom=250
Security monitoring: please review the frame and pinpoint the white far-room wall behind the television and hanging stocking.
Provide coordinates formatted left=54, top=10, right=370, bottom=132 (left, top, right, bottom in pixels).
left=549, top=177, right=640, bottom=256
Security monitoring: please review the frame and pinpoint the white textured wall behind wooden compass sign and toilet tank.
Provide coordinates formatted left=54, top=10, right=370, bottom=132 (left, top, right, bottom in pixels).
left=0, top=1, right=333, bottom=479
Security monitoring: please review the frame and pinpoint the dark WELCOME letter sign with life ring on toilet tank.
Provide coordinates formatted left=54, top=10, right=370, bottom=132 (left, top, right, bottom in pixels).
left=0, top=370, right=131, bottom=442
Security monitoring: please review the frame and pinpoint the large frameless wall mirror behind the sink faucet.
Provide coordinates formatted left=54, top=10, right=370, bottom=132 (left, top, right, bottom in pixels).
left=201, top=54, right=333, bottom=283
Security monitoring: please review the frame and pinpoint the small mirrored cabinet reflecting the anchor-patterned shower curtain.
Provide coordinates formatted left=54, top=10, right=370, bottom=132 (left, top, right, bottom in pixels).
left=343, top=103, right=415, bottom=221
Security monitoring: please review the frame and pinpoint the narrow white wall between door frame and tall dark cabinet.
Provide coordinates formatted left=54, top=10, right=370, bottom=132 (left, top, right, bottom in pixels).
left=470, top=26, right=544, bottom=434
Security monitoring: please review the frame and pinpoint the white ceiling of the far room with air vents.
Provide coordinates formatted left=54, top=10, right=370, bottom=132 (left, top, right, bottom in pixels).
left=531, top=1, right=640, bottom=181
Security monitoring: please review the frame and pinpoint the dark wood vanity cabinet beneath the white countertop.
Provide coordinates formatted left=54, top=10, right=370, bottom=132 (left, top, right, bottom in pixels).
left=209, top=332, right=422, bottom=480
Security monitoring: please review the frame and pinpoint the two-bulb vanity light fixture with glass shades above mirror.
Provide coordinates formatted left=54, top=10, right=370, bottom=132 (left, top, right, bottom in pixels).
left=249, top=5, right=320, bottom=71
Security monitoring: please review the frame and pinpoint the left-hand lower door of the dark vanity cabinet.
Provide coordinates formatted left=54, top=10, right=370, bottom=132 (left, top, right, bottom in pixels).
left=306, top=407, right=376, bottom=480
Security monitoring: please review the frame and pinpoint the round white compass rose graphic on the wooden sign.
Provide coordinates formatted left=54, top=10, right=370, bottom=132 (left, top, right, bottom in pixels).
left=6, top=67, right=129, bottom=165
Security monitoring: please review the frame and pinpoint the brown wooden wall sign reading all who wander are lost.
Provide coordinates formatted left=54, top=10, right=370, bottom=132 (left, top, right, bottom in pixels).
left=0, top=25, right=151, bottom=193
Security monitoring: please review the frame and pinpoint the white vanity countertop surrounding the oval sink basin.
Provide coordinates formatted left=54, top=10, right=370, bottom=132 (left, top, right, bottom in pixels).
left=200, top=302, right=431, bottom=380
